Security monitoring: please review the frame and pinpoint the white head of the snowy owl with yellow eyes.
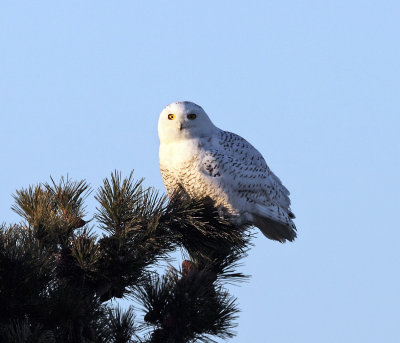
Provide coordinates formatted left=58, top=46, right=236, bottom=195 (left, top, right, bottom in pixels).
left=158, top=101, right=218, bottom=143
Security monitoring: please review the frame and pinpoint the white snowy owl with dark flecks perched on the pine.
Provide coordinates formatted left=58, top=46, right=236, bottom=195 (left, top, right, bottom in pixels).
left=158, top=101, right=296, bottom=242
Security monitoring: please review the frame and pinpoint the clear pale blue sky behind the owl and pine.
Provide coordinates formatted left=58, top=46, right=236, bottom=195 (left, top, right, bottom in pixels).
left=0, top=0, right=400, bottom=343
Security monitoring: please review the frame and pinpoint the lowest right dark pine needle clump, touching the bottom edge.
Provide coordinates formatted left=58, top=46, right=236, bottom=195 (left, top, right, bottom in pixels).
left=135, top=268, right=238, bottom=343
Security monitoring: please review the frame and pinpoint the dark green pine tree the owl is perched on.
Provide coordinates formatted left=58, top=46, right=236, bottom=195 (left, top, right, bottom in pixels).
left=0, top=172, right=251, bottom=343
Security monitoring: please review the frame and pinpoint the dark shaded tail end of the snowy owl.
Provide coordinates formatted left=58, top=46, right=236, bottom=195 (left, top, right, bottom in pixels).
left=253, top=205, right=297, bottom=243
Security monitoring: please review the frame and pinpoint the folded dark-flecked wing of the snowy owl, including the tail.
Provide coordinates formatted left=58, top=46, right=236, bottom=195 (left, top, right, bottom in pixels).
left=201, top=132, right=296, bottom=242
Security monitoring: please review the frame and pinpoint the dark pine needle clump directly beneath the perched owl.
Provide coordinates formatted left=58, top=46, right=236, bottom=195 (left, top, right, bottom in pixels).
left=160, top=193, right=253, bottom=281
